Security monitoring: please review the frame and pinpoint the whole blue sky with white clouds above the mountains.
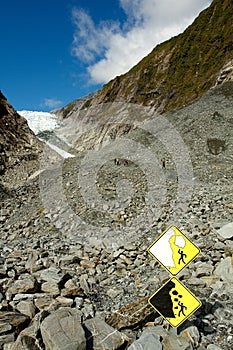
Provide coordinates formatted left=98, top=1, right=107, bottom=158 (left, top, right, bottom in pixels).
left=0, top=0, right=211, bottom=111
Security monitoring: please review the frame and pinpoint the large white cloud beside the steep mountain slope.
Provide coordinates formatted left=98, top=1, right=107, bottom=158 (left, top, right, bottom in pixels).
left=72, top=0, right=212, bottom=84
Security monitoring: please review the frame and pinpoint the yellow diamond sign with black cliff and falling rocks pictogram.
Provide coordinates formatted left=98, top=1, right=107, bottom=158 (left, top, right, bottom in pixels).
left=148, top=277, right=201, bottom=328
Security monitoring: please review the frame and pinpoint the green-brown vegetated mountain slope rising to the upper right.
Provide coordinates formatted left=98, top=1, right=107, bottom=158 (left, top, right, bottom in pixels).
left=57, top=0, right=233, bottom=116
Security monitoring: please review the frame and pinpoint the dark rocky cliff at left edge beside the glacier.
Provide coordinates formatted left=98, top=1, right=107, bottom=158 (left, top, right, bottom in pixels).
left=0, top=91, right=41, bottom=174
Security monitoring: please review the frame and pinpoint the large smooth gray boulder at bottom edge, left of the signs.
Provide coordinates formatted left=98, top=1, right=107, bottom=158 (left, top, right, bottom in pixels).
left=41, top=307, right=86, bottom=350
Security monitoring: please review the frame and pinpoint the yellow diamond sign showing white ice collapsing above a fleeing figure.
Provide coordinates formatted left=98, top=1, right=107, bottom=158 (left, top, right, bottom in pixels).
left=147, top=226, right=200, bottom=276
